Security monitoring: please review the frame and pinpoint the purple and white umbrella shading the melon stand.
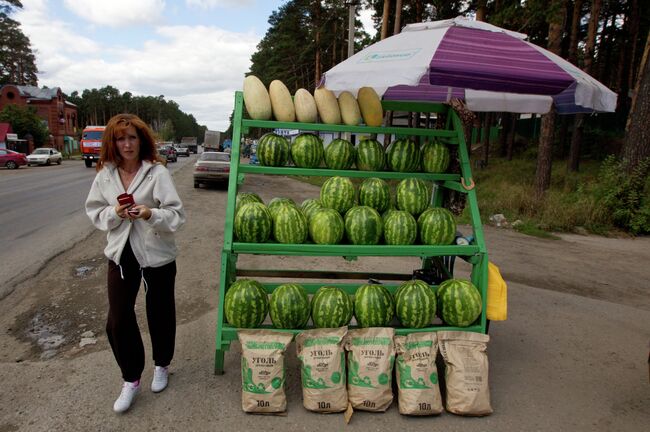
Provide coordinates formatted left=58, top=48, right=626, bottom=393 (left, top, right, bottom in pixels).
left=321, top=17, right=616, bottom=114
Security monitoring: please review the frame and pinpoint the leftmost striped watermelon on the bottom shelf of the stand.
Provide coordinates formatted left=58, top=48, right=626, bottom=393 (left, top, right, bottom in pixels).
left=223, top=279, right=269, bottom=328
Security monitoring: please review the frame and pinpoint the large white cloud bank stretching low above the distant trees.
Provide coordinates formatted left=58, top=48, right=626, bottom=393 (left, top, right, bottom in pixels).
left=17, top=0, right=259, bottom=130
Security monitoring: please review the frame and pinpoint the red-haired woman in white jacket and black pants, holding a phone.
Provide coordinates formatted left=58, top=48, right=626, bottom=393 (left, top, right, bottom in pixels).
left=86, top=114, right=185, bottom=412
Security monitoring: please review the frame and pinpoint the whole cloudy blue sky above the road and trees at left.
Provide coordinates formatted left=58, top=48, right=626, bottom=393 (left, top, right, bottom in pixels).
left=13, top=0, right=371, bottom=131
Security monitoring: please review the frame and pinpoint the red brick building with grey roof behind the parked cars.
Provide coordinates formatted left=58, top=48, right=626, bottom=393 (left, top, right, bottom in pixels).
left=0, top=84, right=77, bottom=152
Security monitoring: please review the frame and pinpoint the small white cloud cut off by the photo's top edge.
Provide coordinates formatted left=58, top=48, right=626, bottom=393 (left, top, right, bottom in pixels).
left=64, top=0, right=165, bottom=27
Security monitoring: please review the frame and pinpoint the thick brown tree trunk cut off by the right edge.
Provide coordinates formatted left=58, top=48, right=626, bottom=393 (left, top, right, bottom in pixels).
left=622, top=33, right=650, bottom=174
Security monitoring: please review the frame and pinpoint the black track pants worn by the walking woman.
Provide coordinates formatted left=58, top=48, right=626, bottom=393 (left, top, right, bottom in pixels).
left=106, top=242, right=176, bottom=382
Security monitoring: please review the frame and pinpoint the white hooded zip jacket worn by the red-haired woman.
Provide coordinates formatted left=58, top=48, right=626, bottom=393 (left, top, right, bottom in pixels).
left=86, top=161, right=185, bottom=268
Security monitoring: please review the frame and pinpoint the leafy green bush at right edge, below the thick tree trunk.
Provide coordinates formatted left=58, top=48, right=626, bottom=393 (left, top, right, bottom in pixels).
left=596, top=156, right=650, bottom=234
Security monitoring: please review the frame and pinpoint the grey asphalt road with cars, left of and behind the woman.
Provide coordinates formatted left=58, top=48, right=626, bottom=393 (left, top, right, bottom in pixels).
left=0, top=155, right=197, bottom=299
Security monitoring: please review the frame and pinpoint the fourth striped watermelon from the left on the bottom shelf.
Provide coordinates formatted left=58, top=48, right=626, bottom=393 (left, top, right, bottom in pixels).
left=354, top=284, right=395, bottom=327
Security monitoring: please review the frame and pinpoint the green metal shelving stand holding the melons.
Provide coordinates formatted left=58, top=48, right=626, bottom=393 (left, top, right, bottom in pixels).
left=214, top=92, right=488, bottom=374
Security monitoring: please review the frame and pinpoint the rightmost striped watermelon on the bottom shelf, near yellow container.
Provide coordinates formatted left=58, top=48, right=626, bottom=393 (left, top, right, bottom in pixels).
left=438, top=279, right=483, bottom=327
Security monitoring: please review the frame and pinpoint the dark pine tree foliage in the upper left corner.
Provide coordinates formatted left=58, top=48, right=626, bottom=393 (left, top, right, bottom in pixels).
left=0, top=0, right=38, bottom=86
